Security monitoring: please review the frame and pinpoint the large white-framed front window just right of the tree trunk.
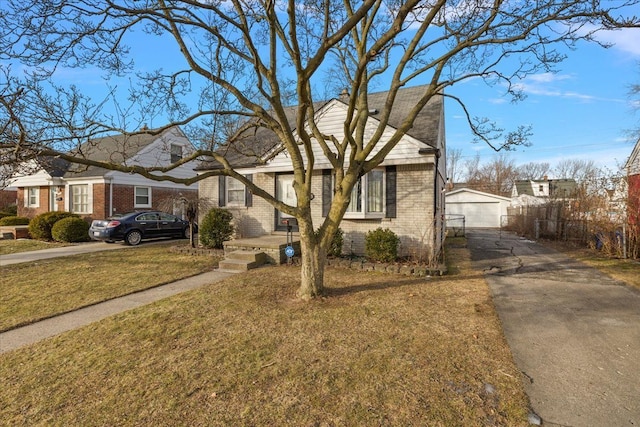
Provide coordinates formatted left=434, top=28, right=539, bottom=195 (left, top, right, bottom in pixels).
left=345, top=170, right=384, bottom=218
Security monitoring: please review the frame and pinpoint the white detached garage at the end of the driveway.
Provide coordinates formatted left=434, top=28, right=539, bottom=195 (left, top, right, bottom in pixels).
left=445, top=188, right=511, bottom=228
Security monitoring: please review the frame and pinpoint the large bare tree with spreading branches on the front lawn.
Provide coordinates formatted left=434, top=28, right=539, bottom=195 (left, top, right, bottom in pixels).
left=0, top=0, right=639, bottom=298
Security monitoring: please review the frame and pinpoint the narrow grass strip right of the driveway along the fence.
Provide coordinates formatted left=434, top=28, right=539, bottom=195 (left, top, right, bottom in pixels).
left=539, top=241, right=640, bottom=288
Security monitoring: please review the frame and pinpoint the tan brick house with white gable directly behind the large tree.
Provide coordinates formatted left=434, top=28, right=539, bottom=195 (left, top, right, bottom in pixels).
left=196, top=87, right=446, bottom=259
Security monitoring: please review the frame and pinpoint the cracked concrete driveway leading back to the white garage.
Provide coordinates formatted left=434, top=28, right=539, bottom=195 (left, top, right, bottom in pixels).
left=467, top=230, right=640, bottom=427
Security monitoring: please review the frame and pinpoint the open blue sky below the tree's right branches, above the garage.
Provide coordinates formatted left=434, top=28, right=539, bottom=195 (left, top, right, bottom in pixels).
left=445, top=29, right=640, bottom=175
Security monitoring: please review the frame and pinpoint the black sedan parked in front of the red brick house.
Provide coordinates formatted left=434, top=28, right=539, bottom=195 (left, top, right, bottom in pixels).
left=89, top=211, right=197, bottom=246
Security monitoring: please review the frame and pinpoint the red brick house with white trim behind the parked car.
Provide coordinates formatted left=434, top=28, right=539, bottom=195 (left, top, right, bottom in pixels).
left=12, top=127, right=198, bottom=219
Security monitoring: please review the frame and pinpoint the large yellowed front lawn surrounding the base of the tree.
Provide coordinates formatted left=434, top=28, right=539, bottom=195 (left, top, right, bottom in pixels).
left=0, top=244, right=527, bottom=426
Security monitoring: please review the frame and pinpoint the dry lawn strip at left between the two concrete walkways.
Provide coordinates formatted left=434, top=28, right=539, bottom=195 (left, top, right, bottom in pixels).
left=0, top=244, right=217, bottom=331
